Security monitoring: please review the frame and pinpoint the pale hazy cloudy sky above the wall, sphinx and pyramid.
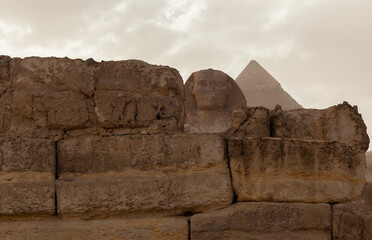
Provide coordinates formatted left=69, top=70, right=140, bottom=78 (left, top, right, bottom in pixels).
left=0, top=0, right=372, bottom=149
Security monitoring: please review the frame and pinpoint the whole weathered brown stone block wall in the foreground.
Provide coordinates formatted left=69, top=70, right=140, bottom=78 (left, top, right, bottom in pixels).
left=0, top=56, right=372, bottom=240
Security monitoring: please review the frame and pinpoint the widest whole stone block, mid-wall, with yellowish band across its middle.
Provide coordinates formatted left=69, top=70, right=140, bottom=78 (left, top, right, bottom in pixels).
left=57, top=134, right=233, bottom=215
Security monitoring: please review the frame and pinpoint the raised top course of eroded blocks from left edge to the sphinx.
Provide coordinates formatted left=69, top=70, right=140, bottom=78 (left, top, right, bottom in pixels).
left=0, top=56, right=184, bottom=140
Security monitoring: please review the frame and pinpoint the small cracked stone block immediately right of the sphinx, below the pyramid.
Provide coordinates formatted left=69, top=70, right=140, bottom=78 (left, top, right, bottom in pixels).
left=226, top=107, right=270, bottom=137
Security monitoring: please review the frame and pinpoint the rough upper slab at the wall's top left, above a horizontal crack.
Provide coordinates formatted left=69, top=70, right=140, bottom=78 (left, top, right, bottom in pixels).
left=10, top=57, right=95, bottom=96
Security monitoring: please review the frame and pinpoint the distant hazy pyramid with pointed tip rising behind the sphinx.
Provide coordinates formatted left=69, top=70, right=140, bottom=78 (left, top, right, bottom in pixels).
left=235, top=60, right=303, bottom=110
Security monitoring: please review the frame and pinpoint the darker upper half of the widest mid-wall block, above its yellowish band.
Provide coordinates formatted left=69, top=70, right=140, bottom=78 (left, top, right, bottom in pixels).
left=58, top=134, right=227, bottom=173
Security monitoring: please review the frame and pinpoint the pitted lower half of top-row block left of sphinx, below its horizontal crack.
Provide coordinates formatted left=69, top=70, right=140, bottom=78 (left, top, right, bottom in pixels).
left=94, top=90, right=183, bottom=130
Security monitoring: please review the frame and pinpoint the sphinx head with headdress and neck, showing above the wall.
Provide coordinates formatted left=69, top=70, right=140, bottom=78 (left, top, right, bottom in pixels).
left=185, top=69, right=247, bottom=133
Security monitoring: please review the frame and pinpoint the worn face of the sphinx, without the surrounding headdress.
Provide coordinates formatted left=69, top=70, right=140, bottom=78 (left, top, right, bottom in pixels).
left=194, top=70, right=229, bottom=110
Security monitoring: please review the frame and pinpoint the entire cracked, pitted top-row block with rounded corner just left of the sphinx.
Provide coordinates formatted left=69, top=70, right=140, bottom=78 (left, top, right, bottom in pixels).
left=94, top=60, right=184, bottom=132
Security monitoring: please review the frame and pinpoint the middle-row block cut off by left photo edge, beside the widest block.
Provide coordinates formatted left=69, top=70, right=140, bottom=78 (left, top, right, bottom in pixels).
left=0, top=137, right=55, bottom=217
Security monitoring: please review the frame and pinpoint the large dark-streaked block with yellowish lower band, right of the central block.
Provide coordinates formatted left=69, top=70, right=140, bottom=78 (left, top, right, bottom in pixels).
left=228, top=138, right=365, bottom=202
